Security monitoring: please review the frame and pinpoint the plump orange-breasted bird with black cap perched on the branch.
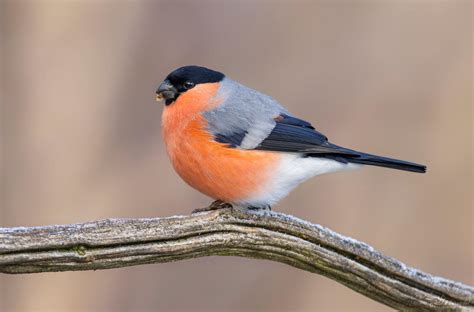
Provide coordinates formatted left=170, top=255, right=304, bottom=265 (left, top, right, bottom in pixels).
left=156, top=66, right=426, bottom=209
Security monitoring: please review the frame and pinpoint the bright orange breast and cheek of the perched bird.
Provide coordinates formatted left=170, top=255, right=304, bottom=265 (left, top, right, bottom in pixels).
left=162, top=83, right=279, bottom=202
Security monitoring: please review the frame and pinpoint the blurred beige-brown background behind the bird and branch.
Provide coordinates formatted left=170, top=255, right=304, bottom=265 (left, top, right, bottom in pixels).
left=0, top=0, right=474, bottom=311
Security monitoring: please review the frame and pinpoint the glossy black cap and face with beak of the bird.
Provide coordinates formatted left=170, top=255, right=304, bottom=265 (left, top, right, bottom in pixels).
left=156, top=65, right=225, bottom=105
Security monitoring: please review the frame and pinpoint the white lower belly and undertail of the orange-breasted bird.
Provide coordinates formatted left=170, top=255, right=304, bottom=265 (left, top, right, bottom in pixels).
left=237, top=153, right=362, bottom=207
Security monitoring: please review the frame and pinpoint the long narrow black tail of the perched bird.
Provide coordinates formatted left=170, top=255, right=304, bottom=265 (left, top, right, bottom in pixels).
left=312, top=144, right=426, bottom=173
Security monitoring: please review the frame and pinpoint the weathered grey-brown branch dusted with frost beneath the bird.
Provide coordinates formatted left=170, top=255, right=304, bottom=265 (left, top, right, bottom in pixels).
left=0, top=209, right=474, bottom=310
